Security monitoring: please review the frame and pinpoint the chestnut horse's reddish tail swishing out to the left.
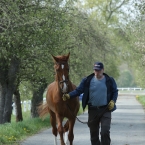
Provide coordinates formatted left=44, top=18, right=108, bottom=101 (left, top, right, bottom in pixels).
left=38, top=102, right=49, bottom=119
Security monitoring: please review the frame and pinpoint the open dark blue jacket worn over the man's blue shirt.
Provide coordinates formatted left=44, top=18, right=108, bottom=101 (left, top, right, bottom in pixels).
left=69, top=73, right=118, bottom=111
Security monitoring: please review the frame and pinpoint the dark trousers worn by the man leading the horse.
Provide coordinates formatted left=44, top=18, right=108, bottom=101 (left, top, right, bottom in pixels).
left=88, top=108, right=111, bottom=145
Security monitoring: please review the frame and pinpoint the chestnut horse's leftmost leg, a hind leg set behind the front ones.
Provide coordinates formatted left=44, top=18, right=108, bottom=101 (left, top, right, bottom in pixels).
left=50, top=110, right=57, bottom=136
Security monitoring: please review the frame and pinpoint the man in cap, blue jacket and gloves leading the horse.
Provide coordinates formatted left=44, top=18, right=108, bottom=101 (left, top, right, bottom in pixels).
left=63, top=62, right=118, bottom=145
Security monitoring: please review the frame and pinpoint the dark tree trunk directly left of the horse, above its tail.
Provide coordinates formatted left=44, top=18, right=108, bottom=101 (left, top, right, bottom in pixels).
left=31, top=84, right=47, bottom=118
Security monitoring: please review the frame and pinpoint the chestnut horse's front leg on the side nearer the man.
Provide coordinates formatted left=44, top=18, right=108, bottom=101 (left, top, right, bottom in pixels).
left=68, top=119, right=75, bottom=145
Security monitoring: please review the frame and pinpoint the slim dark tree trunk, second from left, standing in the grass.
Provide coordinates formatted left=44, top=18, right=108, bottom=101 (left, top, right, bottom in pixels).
left=14, top=89, right=23, bottom=122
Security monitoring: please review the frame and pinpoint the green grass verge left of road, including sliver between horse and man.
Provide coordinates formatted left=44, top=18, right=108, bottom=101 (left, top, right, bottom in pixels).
left=0, top=103, right=83, bottom=145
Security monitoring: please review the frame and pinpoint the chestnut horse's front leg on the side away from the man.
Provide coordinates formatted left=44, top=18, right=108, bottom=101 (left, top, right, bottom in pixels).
left=56, top=114, right=65, bottom=145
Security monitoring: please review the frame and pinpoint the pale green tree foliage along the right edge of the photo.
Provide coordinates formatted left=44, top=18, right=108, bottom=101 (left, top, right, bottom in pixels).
left=122, top=1, right=145, bottom=87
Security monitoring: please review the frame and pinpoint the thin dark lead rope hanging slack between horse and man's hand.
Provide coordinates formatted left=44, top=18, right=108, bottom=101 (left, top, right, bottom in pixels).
left=66, top=103, right=108, bottom=124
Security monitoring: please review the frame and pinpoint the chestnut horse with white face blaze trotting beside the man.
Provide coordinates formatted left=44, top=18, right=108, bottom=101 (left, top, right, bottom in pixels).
left=40, top=53, right=80, bottom=145
